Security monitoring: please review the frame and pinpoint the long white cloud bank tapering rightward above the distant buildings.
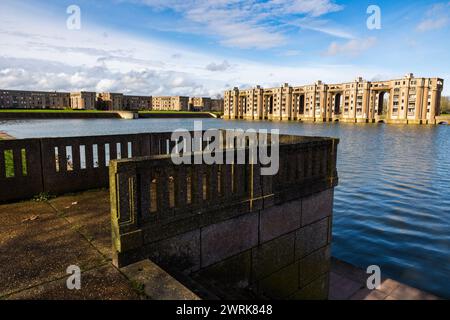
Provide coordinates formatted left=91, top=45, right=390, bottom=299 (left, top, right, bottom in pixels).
left=0, top=0, right=400, bottom=96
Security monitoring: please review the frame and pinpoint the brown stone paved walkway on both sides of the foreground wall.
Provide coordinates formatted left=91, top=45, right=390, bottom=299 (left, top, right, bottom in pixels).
left=0, top=190, right=436, bottom=300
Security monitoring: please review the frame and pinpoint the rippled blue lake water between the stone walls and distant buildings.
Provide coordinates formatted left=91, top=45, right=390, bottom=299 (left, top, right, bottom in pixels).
left=0, top=119, right=450, bottom=298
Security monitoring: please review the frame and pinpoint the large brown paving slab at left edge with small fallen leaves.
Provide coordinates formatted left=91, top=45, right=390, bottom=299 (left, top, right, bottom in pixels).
left=0, top=202, right=105, bottom=297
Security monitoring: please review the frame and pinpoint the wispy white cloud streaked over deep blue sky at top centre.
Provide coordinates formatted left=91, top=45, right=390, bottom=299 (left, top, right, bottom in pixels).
left=132, top=0, right=343, bottom=49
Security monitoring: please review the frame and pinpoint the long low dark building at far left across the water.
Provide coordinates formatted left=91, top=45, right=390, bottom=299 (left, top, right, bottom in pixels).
left=0, top=89, right=70, bottom=109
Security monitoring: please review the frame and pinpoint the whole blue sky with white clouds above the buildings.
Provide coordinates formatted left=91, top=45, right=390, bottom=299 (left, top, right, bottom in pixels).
left=0, top=0, right=450, bottom=96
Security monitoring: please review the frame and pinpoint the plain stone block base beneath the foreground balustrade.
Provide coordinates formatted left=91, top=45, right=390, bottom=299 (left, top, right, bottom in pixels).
left=162, top=189, right=333, bottom=299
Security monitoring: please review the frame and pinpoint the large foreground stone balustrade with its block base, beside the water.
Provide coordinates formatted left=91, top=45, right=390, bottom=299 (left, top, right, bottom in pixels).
left=110, top=131, right=338, bottom=299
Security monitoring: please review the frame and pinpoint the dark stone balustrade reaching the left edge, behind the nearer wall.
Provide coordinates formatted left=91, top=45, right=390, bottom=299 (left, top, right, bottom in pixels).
left=0, top=133, right=176, bottom=202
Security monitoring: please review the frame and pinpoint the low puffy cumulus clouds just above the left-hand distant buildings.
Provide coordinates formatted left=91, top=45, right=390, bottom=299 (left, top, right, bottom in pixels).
left=0, top=58, right=211, bottom=95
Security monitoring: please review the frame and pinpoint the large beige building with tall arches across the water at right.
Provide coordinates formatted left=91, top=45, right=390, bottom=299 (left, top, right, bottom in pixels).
left=224, top=74, right=444, bottom=124
